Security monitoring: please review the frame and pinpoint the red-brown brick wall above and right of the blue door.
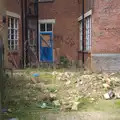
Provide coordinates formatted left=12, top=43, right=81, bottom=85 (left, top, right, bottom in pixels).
left=39, top=0, right=79, bottom=60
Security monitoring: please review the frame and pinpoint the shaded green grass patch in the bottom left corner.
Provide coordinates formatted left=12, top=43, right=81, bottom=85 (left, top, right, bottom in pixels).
left=3, top=103, right=58, bottom=120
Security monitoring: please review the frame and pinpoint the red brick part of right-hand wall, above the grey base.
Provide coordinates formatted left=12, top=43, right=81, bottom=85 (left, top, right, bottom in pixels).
left=92, top=0, right=120, bottom=53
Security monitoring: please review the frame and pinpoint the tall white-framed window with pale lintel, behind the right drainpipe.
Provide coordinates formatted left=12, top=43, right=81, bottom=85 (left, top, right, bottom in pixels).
left=78, top=10, right=92, bottom=52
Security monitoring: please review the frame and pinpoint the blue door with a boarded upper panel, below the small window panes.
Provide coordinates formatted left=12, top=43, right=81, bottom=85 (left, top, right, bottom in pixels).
left=40, top=32, right=53, bottom=62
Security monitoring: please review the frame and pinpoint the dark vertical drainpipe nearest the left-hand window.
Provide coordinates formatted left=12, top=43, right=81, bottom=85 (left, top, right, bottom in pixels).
left=21, top=0, right=25, bottom=68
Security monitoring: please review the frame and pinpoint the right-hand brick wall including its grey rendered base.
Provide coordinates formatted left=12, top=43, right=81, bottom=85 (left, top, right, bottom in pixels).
left=91, top=0, right=120, bottom=72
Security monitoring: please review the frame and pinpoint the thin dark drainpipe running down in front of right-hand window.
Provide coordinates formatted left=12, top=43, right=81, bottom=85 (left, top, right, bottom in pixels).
left=82, top=0, right=85, bottom=68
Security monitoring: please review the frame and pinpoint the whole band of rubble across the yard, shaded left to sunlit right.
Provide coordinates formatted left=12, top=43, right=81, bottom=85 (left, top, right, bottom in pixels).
left=7, top=71, right=120, bottom=110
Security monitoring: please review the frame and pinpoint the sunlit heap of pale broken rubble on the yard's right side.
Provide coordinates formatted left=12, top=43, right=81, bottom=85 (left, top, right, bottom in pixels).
left=53, top=72, right=120, bottom=110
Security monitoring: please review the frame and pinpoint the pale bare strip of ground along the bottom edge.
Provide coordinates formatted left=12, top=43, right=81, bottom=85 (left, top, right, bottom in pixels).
left=40, top=112, right=120, bottom=120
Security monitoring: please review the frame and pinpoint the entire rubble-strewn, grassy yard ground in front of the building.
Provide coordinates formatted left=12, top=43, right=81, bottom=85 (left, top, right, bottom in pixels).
left=3, top=69, right=120, bottom=120
